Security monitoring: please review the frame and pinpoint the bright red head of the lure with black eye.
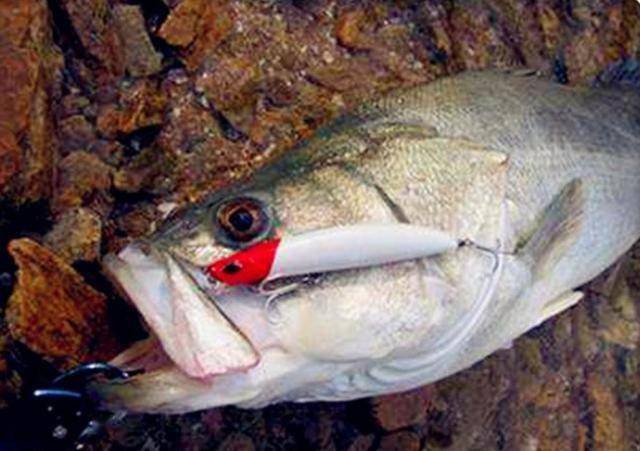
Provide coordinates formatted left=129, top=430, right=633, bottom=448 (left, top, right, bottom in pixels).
left=206, top=239, right=280, bottom=285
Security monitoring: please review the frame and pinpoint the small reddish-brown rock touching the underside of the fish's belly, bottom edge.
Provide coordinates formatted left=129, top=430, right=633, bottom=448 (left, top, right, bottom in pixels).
left=371, top=386, right=434, bottom=431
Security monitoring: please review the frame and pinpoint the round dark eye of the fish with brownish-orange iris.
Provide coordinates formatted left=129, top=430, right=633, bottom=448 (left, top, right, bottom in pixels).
left=214, top=197, right=271, bottom=246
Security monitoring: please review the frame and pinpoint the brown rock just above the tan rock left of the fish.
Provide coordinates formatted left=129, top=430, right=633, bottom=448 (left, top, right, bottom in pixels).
left=53, top=151, right=111, bottom=213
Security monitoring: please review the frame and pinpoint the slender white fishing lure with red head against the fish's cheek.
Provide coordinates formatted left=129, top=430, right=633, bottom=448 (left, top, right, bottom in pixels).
left=206, top=224, right=468, bottom=285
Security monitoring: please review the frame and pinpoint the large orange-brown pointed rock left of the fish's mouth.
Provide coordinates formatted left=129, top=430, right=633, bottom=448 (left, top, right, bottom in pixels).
left=6, top=238, right=118, bottom=369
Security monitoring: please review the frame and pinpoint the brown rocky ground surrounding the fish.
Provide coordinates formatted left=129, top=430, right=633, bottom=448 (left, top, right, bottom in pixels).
left=0, top=0, right=640, bottom=451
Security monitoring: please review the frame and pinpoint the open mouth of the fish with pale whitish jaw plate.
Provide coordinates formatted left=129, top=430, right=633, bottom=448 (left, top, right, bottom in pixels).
left=104, top=243, right=260, bottom=384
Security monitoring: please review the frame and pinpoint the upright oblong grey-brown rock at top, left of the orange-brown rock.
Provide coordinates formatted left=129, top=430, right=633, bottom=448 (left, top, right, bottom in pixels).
left=113, top=5, right=162, bottom=77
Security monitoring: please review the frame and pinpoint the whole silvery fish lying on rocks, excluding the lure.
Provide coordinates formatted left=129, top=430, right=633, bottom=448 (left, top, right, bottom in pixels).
left=90, top=70, right=640, bottom=413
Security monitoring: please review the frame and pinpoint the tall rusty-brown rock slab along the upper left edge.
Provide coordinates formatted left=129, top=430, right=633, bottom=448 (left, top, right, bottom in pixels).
left=0, top=0, right=62, bottom=203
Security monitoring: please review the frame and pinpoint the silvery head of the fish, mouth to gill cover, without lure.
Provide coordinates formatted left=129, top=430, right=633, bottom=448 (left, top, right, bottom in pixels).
left=93, top=127, right=504, bottom=412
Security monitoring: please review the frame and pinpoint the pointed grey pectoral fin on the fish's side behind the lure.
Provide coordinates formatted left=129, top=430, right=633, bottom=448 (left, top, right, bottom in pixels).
left=518, top=179, right=584, bottom=279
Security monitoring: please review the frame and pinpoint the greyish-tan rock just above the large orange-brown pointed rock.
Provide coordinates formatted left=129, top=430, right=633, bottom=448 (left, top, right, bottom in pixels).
left=44, top=208, right=102, bottom=263
